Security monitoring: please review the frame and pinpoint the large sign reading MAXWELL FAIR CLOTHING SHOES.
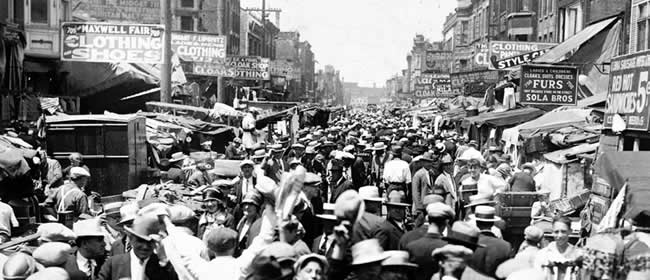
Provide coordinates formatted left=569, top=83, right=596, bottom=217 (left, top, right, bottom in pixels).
left=61, top=22, right=164, bottom=64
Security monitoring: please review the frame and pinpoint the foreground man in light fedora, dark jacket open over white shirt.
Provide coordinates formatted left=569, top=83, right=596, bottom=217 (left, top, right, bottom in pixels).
left=97, top=214, right=178, bottom=280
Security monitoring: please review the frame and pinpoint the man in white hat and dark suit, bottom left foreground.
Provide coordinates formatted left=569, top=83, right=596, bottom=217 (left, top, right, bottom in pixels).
left=64, top=219, right=106, bottom=280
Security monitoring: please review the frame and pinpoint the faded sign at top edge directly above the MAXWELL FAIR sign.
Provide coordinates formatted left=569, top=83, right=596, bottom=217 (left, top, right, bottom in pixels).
left=70, top=0, right=160, bottom=24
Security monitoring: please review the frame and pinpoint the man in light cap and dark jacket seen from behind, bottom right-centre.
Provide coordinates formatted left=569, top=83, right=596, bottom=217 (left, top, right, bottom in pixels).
left=404, top=202, right=454, bottom=280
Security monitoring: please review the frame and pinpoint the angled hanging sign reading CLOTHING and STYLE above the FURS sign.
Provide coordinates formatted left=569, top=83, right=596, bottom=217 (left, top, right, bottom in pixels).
left=488, top=41, right=557, bottom=70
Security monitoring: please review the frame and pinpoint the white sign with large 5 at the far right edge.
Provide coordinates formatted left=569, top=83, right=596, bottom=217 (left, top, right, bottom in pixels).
left=604, top=51, right=650, bottom=131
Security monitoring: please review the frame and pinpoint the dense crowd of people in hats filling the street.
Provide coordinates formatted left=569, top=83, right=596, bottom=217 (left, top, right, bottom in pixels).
left=0, top=107, right=612, bottom=280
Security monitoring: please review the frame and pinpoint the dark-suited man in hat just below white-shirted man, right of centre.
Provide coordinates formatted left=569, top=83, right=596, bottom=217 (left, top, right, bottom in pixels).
left=377, top=189, right=404, bottom=251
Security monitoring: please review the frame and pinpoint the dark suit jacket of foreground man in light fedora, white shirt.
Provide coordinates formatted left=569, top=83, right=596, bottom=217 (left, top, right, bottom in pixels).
left=97, top=253, right=178, bottom=280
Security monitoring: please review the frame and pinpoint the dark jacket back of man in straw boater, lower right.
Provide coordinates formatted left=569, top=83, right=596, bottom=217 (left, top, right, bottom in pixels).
left=470, top=231, right=512, bottom=277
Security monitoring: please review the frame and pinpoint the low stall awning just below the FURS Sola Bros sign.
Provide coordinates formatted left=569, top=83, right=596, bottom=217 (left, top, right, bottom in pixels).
left=462, top=107, right=544, bottom=127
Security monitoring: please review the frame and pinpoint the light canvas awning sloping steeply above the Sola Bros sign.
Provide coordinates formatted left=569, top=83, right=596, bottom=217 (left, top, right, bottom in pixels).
left=533, top=17, right=618, bottom=63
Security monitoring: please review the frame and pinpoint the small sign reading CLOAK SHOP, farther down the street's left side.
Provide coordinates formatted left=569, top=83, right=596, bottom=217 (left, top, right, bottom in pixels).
left=226, top=56, right=271, bottom=80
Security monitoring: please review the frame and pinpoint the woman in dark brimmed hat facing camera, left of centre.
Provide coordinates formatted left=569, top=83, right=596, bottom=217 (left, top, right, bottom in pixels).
left=197, top=188, right=235, bottom=238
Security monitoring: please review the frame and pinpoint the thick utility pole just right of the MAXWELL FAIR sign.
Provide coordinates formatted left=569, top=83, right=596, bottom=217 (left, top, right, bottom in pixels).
left=160, top=0, right=172, bottom=103
